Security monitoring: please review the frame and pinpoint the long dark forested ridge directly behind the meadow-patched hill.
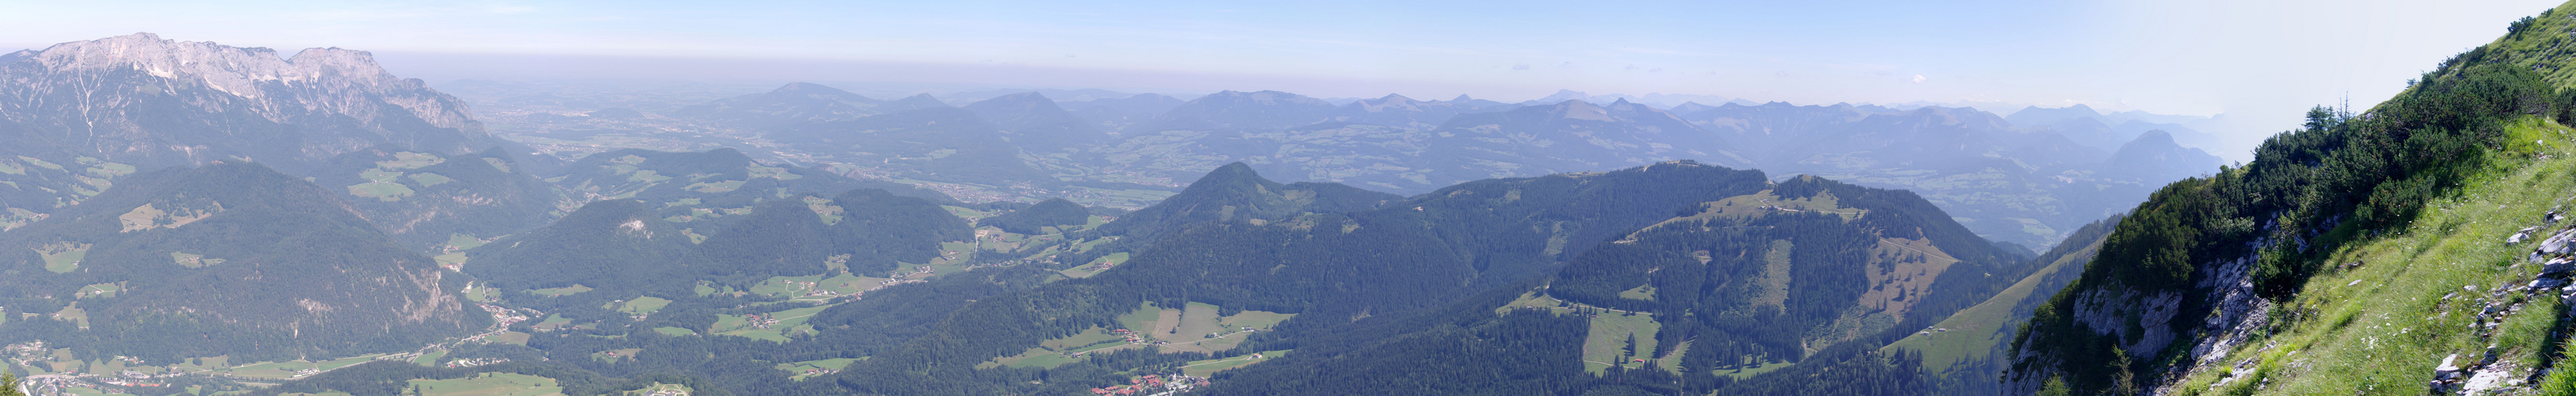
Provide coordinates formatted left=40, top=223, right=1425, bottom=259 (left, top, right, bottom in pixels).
left=813, top=162, right=1767, bottom=394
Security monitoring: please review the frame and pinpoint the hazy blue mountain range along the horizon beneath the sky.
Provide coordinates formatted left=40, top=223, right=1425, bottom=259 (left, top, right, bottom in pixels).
left=526, top=82, right=2220, bottom=247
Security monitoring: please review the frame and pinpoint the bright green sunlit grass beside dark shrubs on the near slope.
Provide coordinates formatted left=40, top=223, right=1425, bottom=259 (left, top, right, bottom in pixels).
left=2175, top=118, right=2576, bottom=394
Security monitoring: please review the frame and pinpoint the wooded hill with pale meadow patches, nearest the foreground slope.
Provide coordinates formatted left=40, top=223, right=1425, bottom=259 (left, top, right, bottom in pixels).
left=1189, top=177, right=2035, bottom=394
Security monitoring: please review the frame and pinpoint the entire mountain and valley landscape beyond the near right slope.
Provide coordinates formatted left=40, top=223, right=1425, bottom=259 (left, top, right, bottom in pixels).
left=0, top=33, right=2216, bottom=394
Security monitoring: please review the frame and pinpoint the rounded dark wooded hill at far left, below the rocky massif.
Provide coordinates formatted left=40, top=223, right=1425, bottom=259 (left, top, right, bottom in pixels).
left=0, top=162, right=492, bottom=363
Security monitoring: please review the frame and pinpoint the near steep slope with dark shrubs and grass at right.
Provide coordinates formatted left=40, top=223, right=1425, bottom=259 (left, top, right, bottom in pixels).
left=2007, top=5, right=2576, bottom=394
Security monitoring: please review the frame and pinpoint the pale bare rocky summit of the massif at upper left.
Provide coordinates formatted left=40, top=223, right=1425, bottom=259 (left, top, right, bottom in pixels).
left=0, top=33, right=492, bottom=173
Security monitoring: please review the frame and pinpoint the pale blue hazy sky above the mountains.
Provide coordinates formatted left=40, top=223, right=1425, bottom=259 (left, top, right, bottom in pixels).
left=0, top=0, right=2555, bottom=159
